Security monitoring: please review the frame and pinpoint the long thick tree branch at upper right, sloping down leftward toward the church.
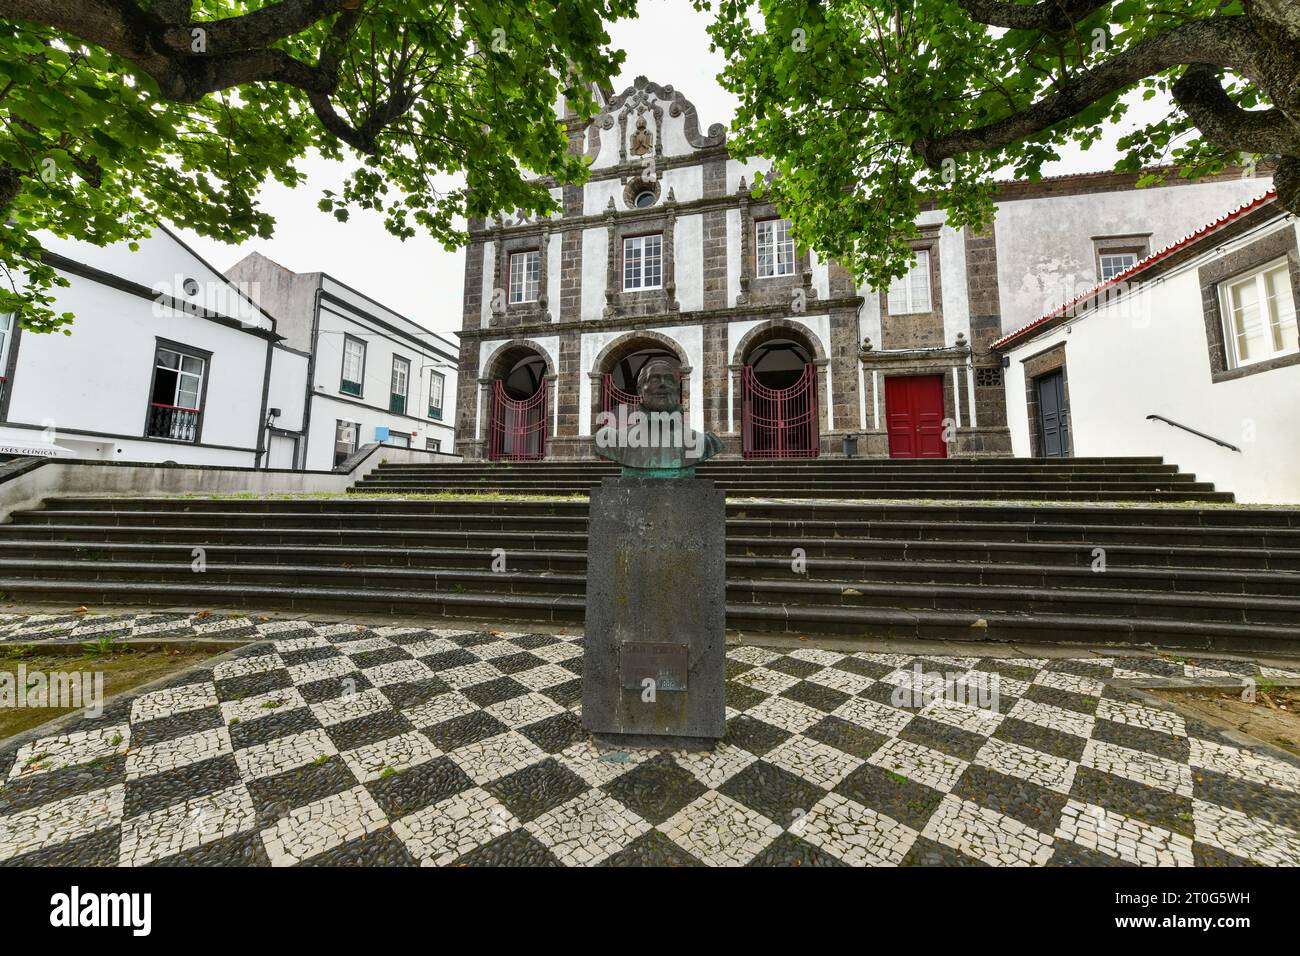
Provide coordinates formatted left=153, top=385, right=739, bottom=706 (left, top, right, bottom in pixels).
left=913, top=17, right=1260, bottom=168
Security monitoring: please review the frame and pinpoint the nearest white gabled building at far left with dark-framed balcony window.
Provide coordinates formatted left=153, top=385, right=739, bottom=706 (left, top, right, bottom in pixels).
left=0, top=221, right=307, bottom=467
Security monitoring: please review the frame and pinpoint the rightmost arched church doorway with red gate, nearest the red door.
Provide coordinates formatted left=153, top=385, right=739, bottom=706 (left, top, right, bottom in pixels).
left=741, top=329, right=818, bottom=458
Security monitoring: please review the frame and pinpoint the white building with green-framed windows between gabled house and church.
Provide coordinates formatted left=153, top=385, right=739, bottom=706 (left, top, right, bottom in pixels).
left=226, top=252, right=460, bottom=470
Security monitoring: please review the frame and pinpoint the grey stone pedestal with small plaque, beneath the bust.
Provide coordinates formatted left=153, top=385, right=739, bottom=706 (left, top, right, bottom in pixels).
left=582, top=477, right=727, bottom=749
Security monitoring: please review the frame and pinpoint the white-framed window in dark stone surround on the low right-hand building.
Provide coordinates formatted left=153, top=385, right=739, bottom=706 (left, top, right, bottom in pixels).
left=1219, top=259, right=1300, bottom=368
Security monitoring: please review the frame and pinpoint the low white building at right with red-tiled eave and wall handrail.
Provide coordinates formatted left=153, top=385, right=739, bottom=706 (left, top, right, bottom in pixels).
left=993, top=185, right=1300, bottom=502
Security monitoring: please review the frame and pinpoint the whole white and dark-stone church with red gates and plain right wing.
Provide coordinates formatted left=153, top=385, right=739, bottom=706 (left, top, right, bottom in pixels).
left=456, top=77, right=1268, bottom=460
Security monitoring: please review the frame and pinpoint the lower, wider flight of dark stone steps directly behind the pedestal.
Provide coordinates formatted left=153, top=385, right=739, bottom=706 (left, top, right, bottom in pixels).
left=0, top=481, right=1300, bottom=653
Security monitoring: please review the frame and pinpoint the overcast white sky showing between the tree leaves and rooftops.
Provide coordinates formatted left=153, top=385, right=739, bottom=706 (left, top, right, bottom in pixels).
left=175, top=0, right=1161, bottom=332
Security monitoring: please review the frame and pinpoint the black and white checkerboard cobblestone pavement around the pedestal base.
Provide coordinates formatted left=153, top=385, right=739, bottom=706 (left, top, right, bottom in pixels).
left=0, top=615, right=1300, bottom=866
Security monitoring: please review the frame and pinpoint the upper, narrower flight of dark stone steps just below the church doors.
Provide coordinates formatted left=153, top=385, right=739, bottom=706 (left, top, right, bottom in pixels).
left=352, top=458, right=1232, bottom=502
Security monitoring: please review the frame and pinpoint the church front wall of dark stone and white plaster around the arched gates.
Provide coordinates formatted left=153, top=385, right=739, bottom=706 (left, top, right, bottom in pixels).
left=456, top=77, right=1268, bottom=459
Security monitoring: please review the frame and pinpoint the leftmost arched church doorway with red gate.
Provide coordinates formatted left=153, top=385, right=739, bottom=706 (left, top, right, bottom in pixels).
left=488, top=345, right=550, bottom=462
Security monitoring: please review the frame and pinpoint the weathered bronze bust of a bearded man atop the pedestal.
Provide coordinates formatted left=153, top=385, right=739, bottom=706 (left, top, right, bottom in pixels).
left=595, top=358, right=723, bottom=477
